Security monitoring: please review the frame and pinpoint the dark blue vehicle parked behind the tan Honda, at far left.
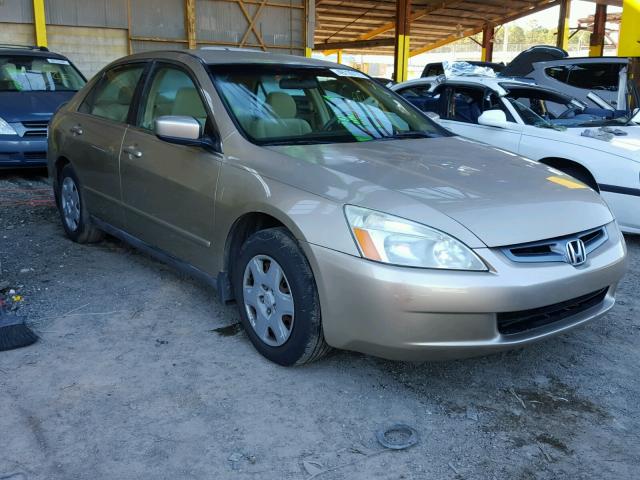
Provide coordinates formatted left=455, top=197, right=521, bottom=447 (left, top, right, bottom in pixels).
left=0, top=45, right=86, bottom=169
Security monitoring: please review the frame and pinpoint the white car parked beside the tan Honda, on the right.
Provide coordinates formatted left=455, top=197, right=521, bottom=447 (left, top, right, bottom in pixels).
left=392, top=76, right=640, bottom=233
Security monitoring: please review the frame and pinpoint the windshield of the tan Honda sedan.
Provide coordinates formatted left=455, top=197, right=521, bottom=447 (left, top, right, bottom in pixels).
left=210, top=65, right=448, bottom=145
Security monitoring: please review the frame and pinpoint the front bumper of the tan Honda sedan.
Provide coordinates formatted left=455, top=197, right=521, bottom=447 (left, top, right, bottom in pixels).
left=305, top=224, right=626, bottom=361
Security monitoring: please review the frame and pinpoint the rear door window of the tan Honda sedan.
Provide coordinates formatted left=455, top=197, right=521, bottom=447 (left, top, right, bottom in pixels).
left=80, top=64, right=144, bottom=122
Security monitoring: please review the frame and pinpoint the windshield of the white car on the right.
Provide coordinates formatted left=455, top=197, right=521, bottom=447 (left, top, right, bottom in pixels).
left=506, top=88, right=629, bottom=129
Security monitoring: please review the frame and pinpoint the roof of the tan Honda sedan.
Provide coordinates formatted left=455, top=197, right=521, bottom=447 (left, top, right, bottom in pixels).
left=123, top=47, right=342, bottom=70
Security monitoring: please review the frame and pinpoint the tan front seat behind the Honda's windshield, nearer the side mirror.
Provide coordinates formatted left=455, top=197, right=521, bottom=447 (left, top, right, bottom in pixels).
left=250, top=92, right=311, bottom=138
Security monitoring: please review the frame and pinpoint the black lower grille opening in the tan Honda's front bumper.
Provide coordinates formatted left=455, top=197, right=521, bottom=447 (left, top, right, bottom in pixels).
left=497, top=288, right=609, bottom=335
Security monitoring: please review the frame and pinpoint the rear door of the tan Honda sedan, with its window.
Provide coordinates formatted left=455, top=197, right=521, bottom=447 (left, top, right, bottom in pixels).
left=61, top=63, right=145, bottom=228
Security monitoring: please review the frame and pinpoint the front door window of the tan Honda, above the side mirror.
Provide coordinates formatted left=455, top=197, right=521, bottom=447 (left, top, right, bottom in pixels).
left=139, top=66, right=207, bottom=130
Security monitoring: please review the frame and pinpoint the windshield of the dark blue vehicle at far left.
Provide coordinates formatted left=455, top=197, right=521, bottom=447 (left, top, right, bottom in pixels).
left=0, top=55, right=85, bottom=92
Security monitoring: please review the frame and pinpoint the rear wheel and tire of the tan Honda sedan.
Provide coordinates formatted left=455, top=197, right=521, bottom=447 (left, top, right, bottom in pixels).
left=56, top=165, right=104, bottom=243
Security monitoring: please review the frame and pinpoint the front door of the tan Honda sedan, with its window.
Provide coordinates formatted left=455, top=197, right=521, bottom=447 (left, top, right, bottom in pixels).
left=120, top=63, right=222, bottom=271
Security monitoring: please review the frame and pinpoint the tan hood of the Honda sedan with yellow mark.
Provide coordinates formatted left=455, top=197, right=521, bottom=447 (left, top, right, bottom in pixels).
left=269, top=137, right=613, bottom=247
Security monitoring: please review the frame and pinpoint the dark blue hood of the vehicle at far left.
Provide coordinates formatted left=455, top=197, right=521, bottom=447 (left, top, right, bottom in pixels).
left=0, top=92, right=76, bottom=122
